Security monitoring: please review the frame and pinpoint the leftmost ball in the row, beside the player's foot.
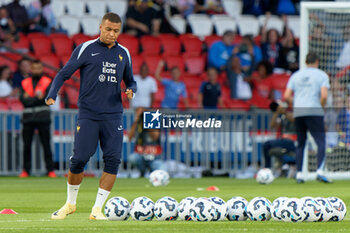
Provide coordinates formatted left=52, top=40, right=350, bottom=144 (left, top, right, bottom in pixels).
left=105, top=197, right=130, bottom=221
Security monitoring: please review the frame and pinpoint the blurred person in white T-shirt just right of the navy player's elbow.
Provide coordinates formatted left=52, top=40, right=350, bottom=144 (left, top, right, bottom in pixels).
left=131, top=63, right=158, bottom=109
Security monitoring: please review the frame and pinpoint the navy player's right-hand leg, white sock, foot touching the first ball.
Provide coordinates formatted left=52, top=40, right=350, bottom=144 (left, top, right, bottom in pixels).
left=90, top=115, right=123, bottom=220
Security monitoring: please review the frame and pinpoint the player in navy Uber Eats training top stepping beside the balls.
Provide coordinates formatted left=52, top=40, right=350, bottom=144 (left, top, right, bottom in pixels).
left=46, top=13, right=136, bottom=220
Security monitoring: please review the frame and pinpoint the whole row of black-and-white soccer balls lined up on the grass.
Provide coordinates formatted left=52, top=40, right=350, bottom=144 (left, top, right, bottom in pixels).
left=104, top=197, right=346, bottom=222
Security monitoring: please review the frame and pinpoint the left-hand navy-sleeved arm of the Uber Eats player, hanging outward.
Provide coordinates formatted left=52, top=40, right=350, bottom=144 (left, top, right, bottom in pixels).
left=46, top=45, right=83, bottom=105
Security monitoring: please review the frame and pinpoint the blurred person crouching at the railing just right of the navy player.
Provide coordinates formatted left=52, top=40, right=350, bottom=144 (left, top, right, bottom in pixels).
left=128, top=108, right=165, bottom=177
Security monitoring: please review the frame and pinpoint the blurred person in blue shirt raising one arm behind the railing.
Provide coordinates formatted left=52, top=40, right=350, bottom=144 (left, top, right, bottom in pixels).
left=154, top=61, right=188, bottom=109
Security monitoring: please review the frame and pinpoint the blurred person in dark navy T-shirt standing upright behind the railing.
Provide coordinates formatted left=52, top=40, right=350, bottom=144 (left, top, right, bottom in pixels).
left=198, top=67, right=225, bottom=109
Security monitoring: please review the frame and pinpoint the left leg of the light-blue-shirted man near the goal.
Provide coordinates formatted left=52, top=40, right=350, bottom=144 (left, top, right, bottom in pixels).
left=294, top=117, right=307, bottom=183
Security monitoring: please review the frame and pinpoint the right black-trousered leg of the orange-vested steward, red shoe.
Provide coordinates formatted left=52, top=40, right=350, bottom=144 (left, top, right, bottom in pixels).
left=36, top=122, right=56, bottom=177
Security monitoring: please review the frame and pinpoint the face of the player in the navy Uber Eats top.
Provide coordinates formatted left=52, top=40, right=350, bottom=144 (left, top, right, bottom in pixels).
left=100, top=19, right=121, bottom=46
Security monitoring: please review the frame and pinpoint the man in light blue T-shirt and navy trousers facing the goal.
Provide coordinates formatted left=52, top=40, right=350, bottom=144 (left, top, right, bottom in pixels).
left=284, top=52, right=331, bottom=183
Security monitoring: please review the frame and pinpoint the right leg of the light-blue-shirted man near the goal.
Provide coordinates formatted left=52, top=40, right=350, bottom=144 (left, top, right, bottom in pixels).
left=306, top=116, right=332, bottom=183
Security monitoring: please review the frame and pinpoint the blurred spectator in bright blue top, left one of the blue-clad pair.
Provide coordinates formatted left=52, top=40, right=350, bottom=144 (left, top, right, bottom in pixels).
left=208, top=31, right=236, bottom=72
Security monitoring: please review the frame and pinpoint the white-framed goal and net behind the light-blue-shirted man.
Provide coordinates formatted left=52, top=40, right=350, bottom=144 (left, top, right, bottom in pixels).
left=300, top=2, right=350, bottom=179
